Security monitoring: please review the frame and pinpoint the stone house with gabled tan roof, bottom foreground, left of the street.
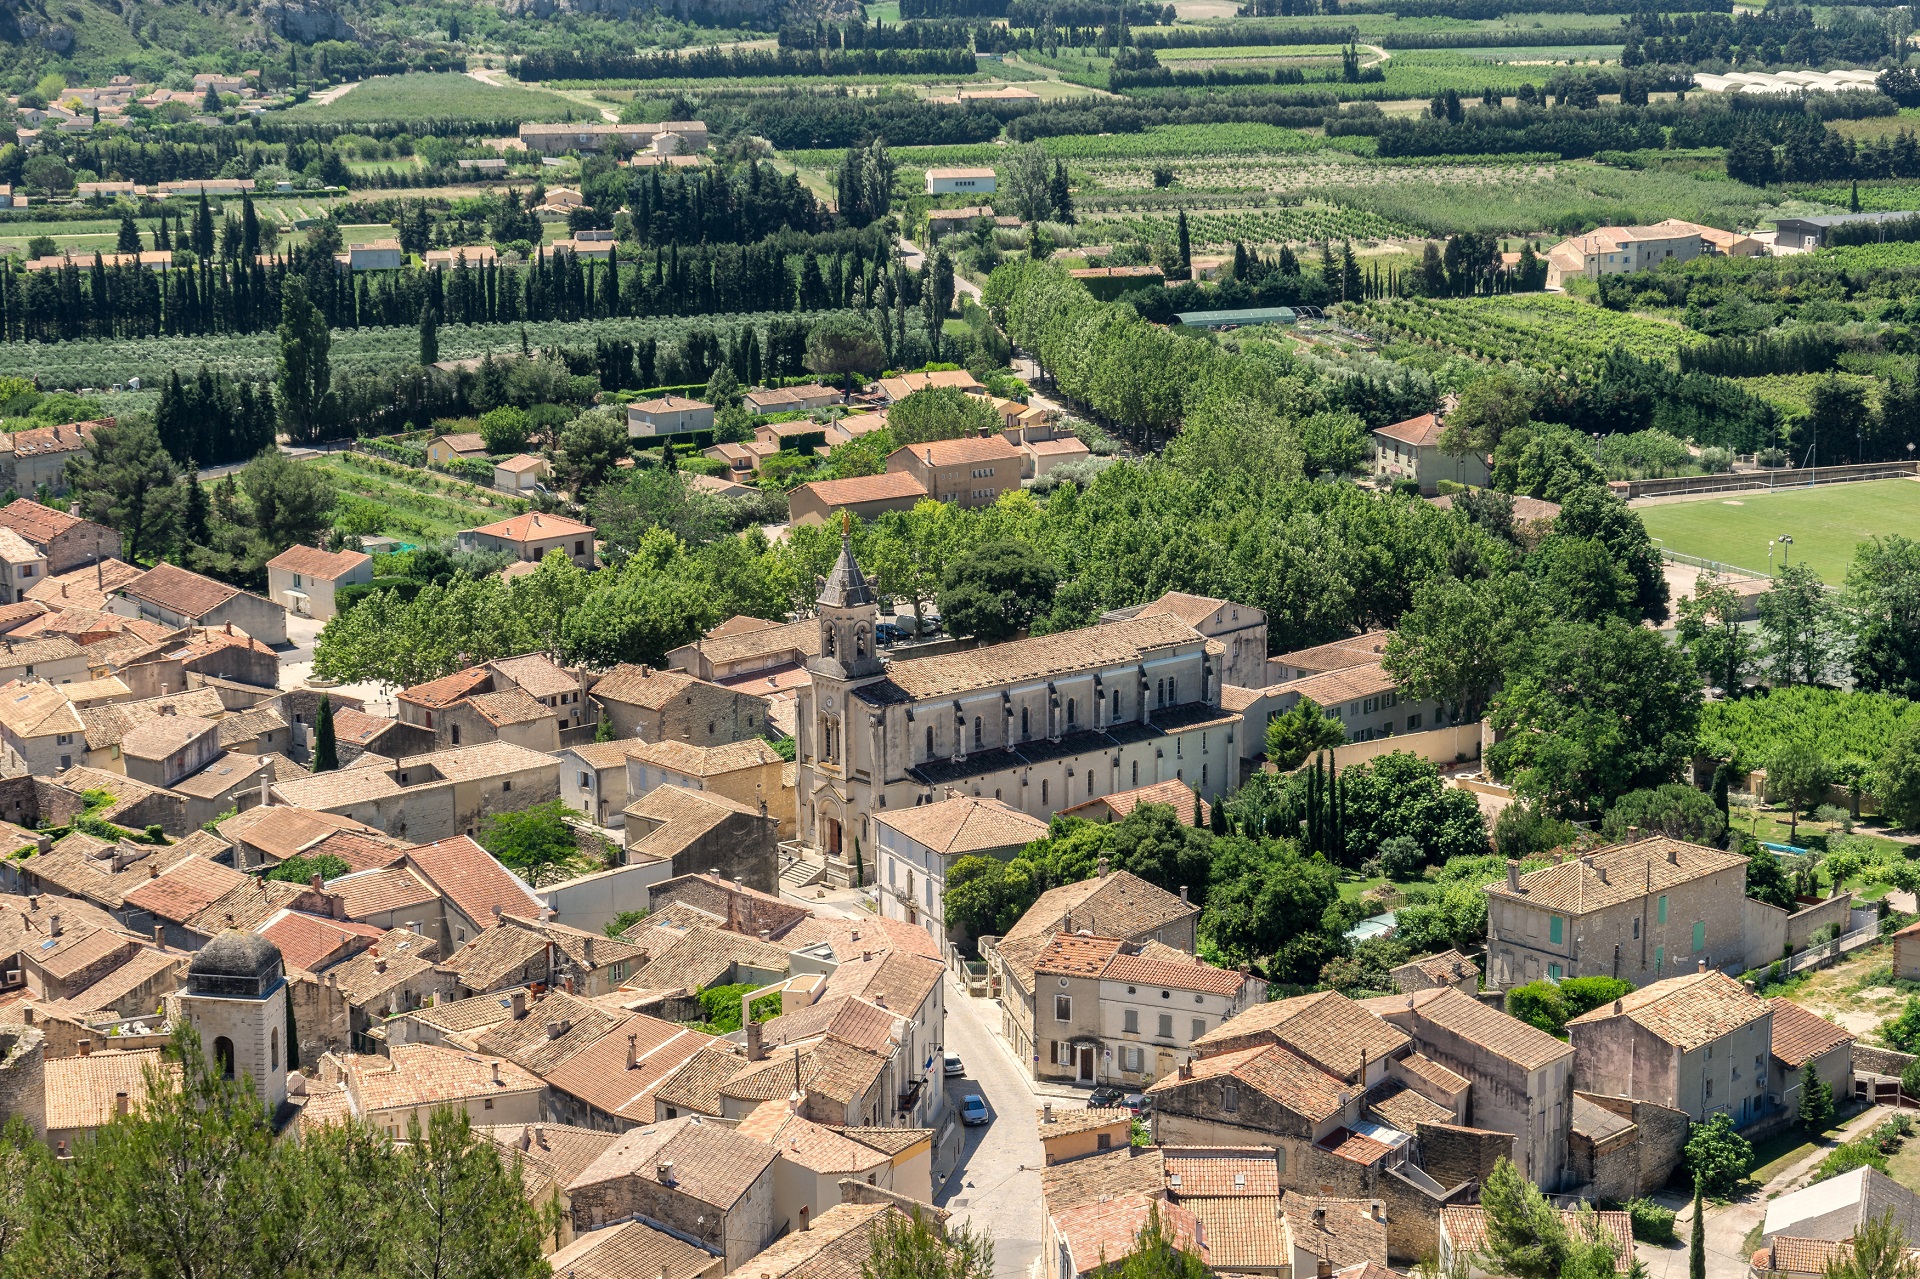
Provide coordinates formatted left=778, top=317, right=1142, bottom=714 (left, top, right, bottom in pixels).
left=566, top=1116, right=778, bottom=1273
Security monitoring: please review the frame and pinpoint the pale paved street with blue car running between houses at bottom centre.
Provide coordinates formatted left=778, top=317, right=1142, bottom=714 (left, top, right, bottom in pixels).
left=933, top=974, right=1043, bottom=1279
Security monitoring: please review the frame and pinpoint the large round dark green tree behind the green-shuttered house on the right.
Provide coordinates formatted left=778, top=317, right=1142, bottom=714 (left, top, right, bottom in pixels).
left=1488, top=620, right=1701, bottom=816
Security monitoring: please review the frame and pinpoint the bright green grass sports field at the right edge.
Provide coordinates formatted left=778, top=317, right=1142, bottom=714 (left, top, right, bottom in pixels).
left=1640, top=480, right=1920, bottom=584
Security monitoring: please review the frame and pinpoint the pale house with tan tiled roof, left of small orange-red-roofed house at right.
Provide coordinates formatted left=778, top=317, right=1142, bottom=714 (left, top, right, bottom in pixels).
left=1567, top=966, right=1774, bottom=1127
